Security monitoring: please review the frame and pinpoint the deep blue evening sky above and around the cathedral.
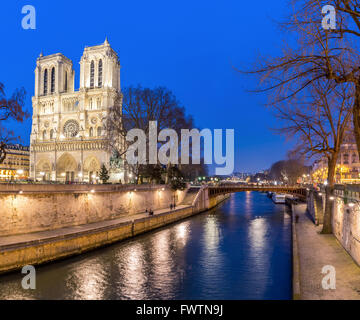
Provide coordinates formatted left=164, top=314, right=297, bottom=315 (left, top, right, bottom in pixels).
left=0, top=0, right=290, bottom=171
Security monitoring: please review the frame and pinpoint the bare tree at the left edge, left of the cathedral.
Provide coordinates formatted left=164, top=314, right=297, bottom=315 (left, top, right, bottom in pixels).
left=0, top=82, right=29, bottom=163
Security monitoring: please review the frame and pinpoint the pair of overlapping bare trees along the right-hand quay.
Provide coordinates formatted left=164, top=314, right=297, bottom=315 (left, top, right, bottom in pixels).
left=248, top=0, right=360, bottom=233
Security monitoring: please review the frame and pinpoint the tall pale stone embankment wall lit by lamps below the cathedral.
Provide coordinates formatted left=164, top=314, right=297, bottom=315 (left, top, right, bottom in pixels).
left=0, top=185, right=186, bottom=236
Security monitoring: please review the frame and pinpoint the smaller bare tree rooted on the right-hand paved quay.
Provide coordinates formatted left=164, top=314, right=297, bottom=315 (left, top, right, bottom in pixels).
left=276, top=80, right=353, bottom=233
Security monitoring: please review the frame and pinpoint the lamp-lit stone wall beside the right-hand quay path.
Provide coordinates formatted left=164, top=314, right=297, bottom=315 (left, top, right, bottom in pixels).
left=308, top=185, right=360, bottom=265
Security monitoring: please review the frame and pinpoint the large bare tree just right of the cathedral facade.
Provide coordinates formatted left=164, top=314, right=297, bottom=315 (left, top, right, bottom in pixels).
left=106, top=86, right=193, bottom=182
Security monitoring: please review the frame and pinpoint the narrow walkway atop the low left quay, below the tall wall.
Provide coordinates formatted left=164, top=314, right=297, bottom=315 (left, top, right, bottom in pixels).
left=0, top=205, right=191, bottom=251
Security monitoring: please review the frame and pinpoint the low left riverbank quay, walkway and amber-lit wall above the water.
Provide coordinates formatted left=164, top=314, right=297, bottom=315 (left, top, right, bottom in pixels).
left=0, top=191, right=228, bottom=273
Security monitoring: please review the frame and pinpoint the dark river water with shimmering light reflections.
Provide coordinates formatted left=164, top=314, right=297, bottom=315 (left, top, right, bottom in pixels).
left=0, top=192, right=292, bottom=299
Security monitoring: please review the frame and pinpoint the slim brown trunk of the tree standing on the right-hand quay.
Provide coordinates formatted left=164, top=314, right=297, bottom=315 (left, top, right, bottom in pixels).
left=321, top=154, right=337, bottom=234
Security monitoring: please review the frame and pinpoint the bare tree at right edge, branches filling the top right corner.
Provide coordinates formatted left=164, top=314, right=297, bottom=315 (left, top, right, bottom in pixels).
left=279, top=0, right=360, bottom=158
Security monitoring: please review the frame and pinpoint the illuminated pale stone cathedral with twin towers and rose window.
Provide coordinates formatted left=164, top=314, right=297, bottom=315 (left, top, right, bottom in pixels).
left=30, top=39, right=126, bottom=183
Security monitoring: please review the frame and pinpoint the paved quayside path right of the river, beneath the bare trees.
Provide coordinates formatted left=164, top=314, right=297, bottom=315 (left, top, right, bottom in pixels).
left=295, top=205, right=360, bottom=300
